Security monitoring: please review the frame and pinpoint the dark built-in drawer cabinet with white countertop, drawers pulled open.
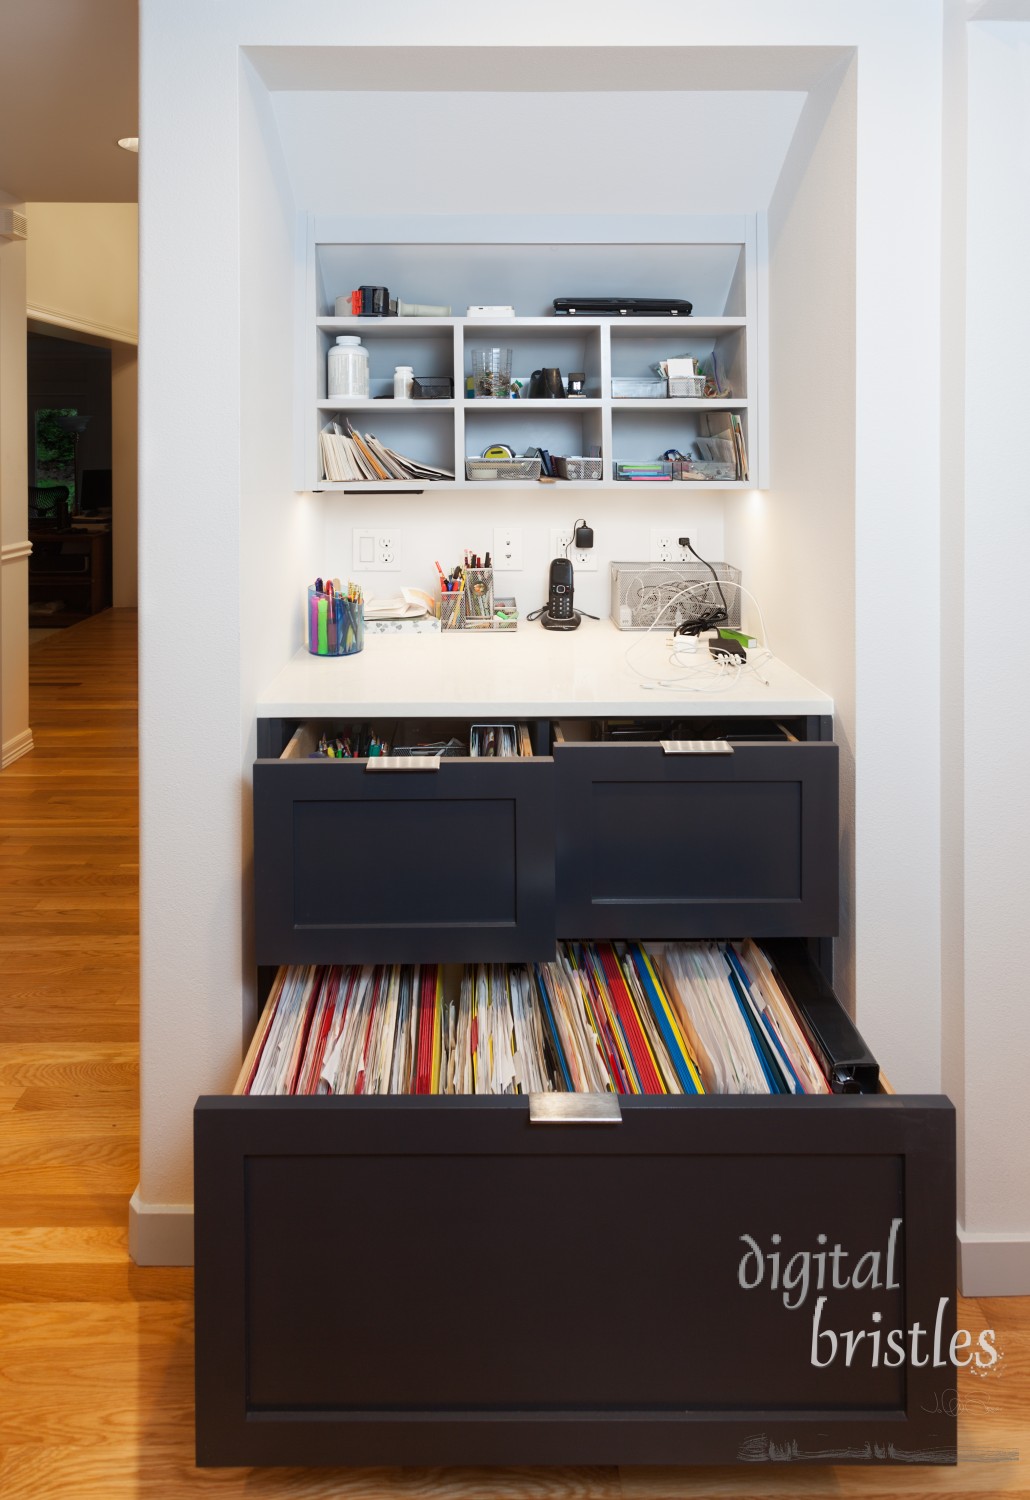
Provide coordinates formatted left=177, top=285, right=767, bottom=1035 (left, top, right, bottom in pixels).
left=195, top=621, right=955, bottom=1464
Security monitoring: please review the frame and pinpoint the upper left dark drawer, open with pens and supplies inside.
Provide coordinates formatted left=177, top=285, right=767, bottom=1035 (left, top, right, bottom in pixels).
left=253, top=720, right=555, bottom=965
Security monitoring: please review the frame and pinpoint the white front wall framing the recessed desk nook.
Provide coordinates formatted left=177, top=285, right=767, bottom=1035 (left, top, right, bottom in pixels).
left=133, top=0, right=942, bottom=1259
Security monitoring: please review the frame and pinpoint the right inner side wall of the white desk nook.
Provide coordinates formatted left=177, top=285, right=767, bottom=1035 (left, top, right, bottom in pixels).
left=740, top=60, right=867, bottom=1026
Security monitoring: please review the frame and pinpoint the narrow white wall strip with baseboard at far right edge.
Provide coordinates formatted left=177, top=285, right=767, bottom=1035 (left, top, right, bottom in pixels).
left=943, top=21, right=1030, bottom=1293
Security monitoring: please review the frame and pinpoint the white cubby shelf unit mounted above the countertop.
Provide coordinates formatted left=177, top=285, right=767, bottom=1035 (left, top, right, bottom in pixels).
left=298, top=216, right=765, bottom=491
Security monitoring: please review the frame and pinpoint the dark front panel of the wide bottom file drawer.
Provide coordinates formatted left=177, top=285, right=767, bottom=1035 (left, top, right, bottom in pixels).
left=195, top=1095, right=955, bottom=1466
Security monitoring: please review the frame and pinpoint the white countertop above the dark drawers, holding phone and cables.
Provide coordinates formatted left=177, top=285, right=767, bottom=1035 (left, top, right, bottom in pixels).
left=256, top=620, right=834, bottom=719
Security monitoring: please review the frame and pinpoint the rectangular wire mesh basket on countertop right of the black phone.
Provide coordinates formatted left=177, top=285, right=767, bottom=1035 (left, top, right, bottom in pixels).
left=612, top=561, right=741, bottom=630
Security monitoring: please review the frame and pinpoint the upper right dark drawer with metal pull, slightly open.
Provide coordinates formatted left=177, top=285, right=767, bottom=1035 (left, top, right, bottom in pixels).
left=555, top=726, right=838, bottom=939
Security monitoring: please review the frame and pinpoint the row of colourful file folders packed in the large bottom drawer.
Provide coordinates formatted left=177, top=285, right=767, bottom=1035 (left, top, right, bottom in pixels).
left=241, top=942, right=831, bottom=1095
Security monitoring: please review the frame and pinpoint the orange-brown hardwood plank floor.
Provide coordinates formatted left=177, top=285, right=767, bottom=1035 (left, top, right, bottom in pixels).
left=0, top=611, right=1030, bottom=1500
